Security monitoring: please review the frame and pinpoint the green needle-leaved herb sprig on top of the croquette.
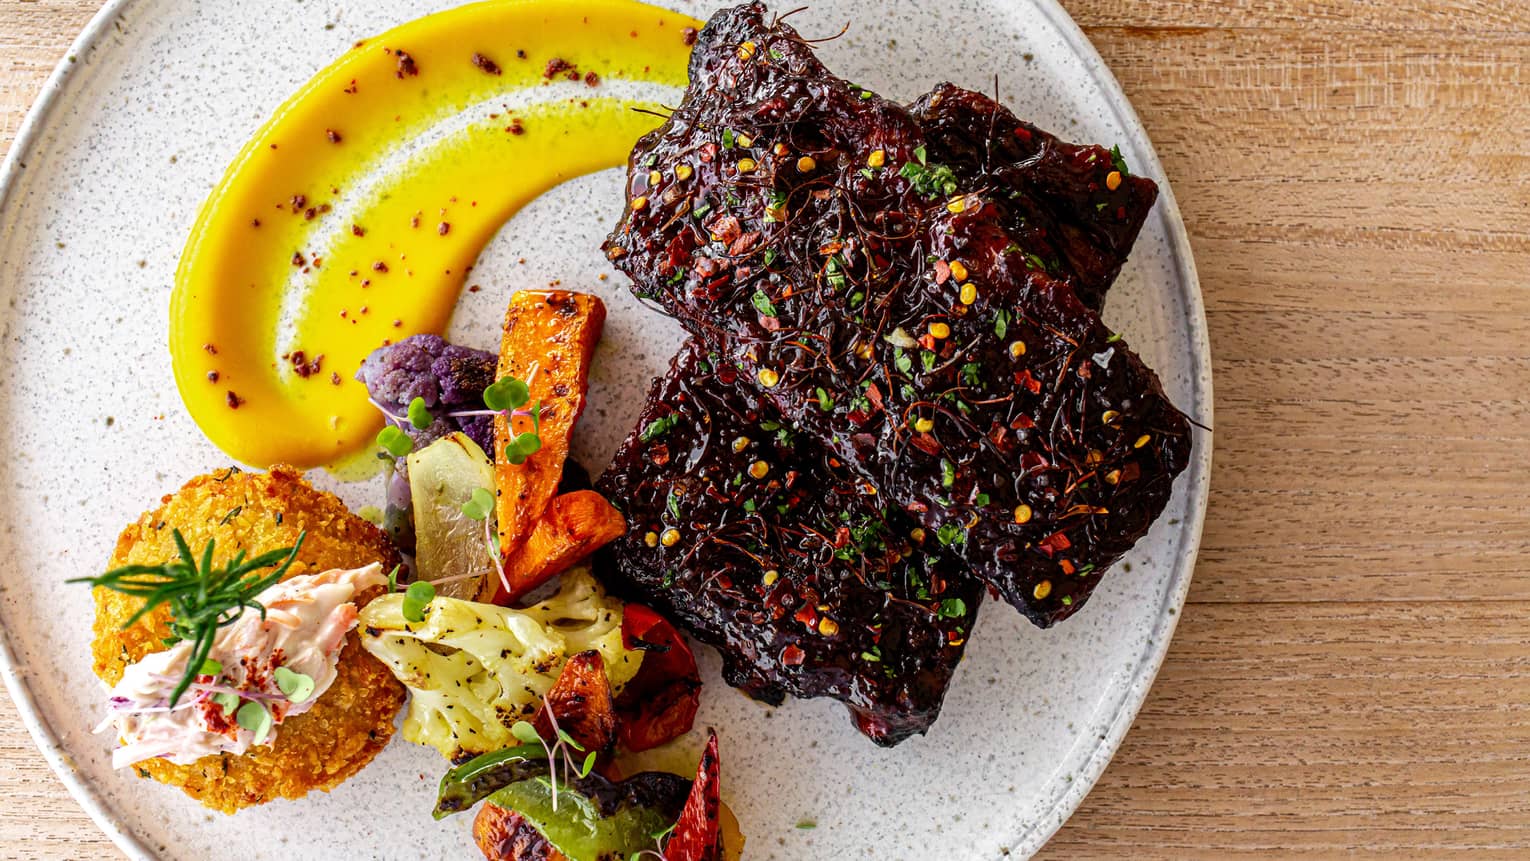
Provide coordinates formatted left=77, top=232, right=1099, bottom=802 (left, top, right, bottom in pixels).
left=69, top=529, right=308, bottom=708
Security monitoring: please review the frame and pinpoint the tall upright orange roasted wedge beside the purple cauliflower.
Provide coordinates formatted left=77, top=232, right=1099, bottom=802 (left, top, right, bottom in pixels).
left=494, top=291, right=606, bottom=568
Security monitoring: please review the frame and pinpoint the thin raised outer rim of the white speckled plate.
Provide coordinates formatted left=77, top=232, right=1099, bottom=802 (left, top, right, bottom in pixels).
left=0, top=0, right=1213, bottom=861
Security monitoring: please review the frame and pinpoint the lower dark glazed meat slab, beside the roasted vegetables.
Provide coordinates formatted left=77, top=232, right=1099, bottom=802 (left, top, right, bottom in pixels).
left=598, top=343, right=982, bottom=746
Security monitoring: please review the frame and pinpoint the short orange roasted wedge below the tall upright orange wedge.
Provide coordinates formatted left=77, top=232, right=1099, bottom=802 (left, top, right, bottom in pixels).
left=479, top=491, right=627, bottom=604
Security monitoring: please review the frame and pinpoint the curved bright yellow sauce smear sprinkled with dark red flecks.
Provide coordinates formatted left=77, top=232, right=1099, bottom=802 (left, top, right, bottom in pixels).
left=170, top=0, right=699, bottom=466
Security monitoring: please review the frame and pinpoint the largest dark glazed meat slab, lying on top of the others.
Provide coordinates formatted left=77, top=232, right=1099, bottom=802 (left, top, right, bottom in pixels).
left=606, top=5, right=1190, bottom=627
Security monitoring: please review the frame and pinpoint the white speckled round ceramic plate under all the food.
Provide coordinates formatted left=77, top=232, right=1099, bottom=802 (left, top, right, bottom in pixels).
left=0, top=0, right=1212, bottom=861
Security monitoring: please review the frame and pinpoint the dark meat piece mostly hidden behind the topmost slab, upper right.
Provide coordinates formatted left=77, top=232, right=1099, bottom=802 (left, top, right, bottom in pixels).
left=909, top=84, right=1158, bottom=312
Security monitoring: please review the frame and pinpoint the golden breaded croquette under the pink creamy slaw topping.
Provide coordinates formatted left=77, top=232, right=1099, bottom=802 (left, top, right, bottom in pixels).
left=92, top=466, right=404, bottom=814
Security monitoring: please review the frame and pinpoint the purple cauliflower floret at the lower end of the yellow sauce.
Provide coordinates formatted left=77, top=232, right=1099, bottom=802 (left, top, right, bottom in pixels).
left=356, top=335, right=499, bottom=451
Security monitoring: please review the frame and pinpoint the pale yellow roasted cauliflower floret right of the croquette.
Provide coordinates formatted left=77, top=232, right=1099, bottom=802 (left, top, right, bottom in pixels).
left=360, top=567, right=643, bottom=760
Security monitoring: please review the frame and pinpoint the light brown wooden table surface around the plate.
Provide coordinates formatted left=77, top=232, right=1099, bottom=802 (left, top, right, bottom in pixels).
left=0, top=0, right=1530, bottom=859
